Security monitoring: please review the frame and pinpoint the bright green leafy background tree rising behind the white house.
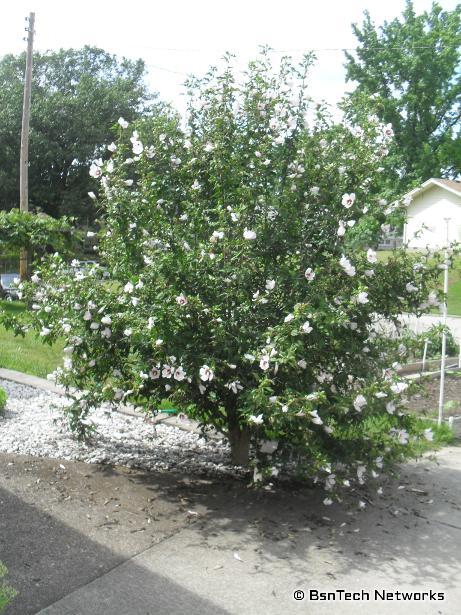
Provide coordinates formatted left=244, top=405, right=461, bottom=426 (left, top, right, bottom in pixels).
left=346, top=0, right=461, bottom=198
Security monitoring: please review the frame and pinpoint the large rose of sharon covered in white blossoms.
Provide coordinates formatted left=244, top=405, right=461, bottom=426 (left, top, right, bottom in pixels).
left=13, top=53, right=446, bottom=496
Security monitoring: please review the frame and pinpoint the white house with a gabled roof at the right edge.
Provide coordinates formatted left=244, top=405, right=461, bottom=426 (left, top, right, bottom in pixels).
left=403, top=178, right=461, bottom=250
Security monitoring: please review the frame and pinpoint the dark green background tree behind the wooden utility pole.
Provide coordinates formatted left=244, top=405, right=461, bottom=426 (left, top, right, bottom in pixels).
left=0, top=47, right=152, bottom=220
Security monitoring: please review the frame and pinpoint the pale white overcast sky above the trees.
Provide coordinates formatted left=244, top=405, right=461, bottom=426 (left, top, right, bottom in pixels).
left=0, top=0, right=457, bottom=114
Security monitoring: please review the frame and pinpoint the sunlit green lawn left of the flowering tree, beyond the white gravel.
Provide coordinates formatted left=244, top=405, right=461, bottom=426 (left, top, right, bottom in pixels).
left=0, top=301, right=64, bottom=378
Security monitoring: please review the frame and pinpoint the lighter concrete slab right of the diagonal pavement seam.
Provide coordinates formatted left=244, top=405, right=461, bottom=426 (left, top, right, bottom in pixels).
left=33, top=447, right=461, bottom=615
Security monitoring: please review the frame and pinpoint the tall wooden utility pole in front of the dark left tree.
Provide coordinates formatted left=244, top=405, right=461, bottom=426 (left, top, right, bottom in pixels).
left=19, top=13, right=35, bottom=280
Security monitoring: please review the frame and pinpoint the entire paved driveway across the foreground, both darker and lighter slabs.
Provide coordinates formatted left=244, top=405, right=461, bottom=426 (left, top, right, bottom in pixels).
left=0, top=447, right=461, bottom=615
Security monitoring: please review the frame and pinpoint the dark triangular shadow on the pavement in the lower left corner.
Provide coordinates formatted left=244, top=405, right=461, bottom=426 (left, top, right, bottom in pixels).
left=0, top=488, right=227, bottom=615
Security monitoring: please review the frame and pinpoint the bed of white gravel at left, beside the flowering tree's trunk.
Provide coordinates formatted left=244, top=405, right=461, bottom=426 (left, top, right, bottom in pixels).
left=0, top=380, right=239, bottom=476
